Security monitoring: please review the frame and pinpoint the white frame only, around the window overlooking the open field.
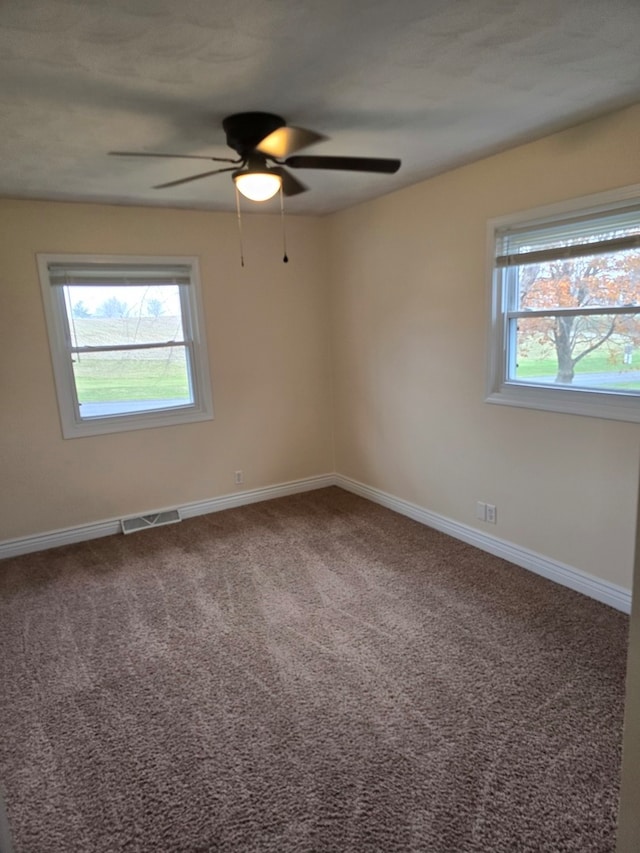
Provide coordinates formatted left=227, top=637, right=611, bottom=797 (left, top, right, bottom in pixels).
left=36, top=253, right=213, bottom=438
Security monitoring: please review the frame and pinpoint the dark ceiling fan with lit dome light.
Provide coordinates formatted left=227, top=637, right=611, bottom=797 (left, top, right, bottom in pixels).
left=109, top=112, right=400, bottom=201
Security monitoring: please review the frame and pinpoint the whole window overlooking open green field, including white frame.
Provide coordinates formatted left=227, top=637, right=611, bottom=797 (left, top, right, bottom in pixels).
left=38, top=255, right=213, bottom=438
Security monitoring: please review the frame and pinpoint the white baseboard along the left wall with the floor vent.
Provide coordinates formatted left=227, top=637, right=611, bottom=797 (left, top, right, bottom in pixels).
left=0, top=474, right=336, bottom=560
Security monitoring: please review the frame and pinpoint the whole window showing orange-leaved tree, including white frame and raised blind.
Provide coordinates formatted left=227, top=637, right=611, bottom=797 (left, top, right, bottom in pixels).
left=487, top=187, right=640, bottom=421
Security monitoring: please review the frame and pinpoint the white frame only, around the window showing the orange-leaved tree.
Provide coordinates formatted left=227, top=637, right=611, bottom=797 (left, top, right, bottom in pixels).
left=485, top=184, right=640, bottom=423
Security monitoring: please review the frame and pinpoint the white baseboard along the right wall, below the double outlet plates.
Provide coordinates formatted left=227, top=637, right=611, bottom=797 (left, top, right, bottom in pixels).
left=334, top=474, right=631, bottom=613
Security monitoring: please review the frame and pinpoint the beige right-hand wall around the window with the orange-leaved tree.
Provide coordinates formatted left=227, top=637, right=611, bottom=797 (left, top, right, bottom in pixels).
left=329, top=107, right=640, bottom=589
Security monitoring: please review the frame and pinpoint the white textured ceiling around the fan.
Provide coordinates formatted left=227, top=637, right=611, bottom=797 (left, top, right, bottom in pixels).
left=0, top=0, right=640, bottom=213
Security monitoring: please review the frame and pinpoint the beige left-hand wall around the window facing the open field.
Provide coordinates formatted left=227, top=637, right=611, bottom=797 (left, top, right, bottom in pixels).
left=0, top=200, right=333, bottom=541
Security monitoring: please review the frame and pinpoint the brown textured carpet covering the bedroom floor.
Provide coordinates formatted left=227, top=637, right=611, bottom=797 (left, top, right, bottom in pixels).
left=0, top=488, right=627, bottom=853
